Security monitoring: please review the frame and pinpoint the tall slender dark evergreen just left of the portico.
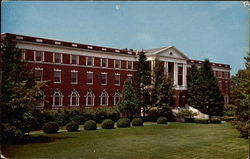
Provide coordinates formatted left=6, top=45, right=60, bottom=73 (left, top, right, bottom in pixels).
left=132, top=50, right=151, bottom=115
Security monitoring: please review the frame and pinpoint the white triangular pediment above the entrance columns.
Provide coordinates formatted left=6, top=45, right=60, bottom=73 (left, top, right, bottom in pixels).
left=155, top=46, right=188, bottom=59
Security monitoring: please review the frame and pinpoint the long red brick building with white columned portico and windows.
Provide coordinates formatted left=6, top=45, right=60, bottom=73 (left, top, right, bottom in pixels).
left=1, top=33, right=230, bottom=109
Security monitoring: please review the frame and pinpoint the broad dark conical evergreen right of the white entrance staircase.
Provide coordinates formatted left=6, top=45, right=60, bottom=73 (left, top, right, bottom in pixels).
left=196, top=59, right=224, bottom=118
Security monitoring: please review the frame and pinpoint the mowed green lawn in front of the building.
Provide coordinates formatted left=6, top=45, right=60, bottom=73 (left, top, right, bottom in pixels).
left=2, top=123, right=248, bottom=159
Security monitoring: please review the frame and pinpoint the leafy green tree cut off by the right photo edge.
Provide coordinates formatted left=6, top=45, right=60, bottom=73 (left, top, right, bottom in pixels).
left=230, top=53, right=250, bottom=137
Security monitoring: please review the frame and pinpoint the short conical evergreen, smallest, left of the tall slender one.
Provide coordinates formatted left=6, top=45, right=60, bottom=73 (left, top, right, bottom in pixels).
left=118, top=80, right=141, bottom=117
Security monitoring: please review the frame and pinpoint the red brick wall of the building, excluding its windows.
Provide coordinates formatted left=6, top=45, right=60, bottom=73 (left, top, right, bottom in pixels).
left=1, top=34, right=230, bottom=109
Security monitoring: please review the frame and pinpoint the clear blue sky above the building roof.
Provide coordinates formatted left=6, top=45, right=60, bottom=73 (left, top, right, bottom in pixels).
left=1, top=1, right=249, bottom=74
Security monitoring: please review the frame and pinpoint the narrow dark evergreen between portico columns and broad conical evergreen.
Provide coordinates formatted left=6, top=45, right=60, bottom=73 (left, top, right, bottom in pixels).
left=187, top=65, right=200, bottom=109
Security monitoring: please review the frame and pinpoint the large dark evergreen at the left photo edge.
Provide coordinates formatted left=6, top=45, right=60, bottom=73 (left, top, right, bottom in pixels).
left=0, top=39, right=45, bottom=139
